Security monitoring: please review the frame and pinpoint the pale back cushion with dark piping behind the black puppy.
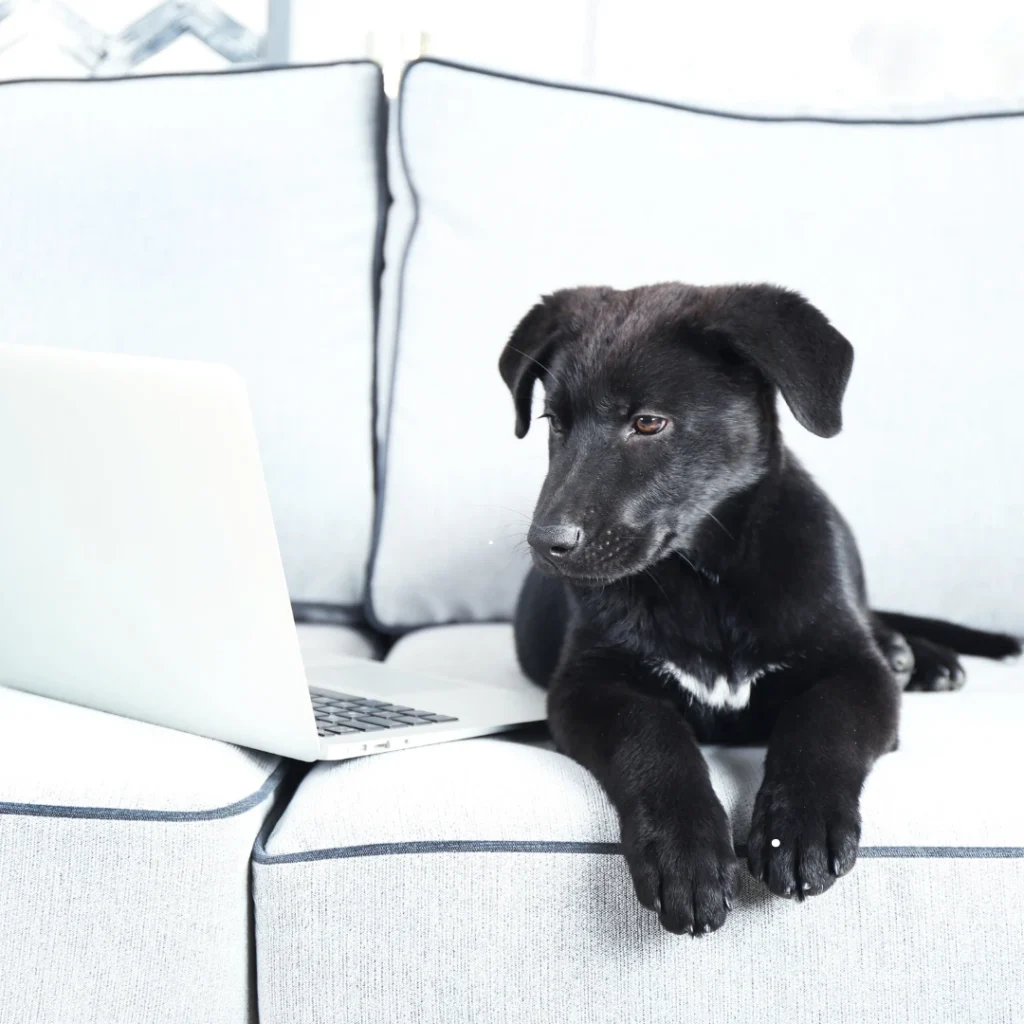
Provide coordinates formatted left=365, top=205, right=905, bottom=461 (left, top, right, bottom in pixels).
left=371, top=61, right=1024, bottom=630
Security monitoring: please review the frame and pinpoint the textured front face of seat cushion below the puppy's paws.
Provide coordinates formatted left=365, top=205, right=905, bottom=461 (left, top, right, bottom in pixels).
left=255, top=852, right=1024, bottom=1024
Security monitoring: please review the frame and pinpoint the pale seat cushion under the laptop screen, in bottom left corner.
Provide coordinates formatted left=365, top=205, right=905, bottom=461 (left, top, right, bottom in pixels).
left=0, top=688, right=285, bottom=1024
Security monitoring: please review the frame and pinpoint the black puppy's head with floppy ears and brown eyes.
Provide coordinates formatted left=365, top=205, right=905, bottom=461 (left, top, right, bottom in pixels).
left=499, top=285, right=853, bottom=583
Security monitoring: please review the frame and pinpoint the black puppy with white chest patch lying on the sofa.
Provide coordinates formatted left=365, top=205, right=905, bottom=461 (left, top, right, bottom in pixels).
left=500, top=285, right=1020, bottom=934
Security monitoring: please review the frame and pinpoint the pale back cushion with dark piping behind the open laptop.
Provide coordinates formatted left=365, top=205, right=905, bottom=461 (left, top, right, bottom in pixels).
left=0, top=61, right=385, bottom=614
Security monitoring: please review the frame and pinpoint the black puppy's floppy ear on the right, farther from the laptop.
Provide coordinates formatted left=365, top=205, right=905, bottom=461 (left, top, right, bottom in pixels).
left=705, top=285, right=853, bottom=437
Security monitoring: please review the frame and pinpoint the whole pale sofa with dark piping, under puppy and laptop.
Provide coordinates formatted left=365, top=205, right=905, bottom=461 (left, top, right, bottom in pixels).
left=0, top=59, right=1024, bottom=1024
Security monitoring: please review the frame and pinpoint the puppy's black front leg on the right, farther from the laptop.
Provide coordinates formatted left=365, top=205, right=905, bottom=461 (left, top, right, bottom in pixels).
left=748, top=656, right=900, bottom=898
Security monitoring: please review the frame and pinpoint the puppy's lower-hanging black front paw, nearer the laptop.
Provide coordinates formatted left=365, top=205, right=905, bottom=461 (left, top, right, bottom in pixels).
left=623, top=808, right=738, bottom=935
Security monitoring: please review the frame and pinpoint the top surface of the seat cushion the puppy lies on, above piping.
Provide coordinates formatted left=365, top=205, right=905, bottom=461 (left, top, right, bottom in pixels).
left=266, top=625, right=1024, bottom=854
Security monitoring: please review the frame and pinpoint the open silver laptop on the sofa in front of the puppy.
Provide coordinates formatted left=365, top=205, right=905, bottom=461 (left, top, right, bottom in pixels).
left=0, top=345, right=545, bottom=761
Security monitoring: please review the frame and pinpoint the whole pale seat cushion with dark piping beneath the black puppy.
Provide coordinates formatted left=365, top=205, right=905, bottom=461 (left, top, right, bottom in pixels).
left=254, top=627, right=1024, bottom=1024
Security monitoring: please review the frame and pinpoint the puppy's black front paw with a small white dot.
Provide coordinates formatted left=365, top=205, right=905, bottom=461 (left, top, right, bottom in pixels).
left=746, top=780, right=860, bottom=899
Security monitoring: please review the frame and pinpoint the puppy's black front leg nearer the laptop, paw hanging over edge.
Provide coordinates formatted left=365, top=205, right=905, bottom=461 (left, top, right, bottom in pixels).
left=548, top=650, right=737, bottom=935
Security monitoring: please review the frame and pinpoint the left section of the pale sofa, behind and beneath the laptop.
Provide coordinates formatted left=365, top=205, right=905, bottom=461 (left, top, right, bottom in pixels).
left=0, top=61, right=387, bottom=1024
